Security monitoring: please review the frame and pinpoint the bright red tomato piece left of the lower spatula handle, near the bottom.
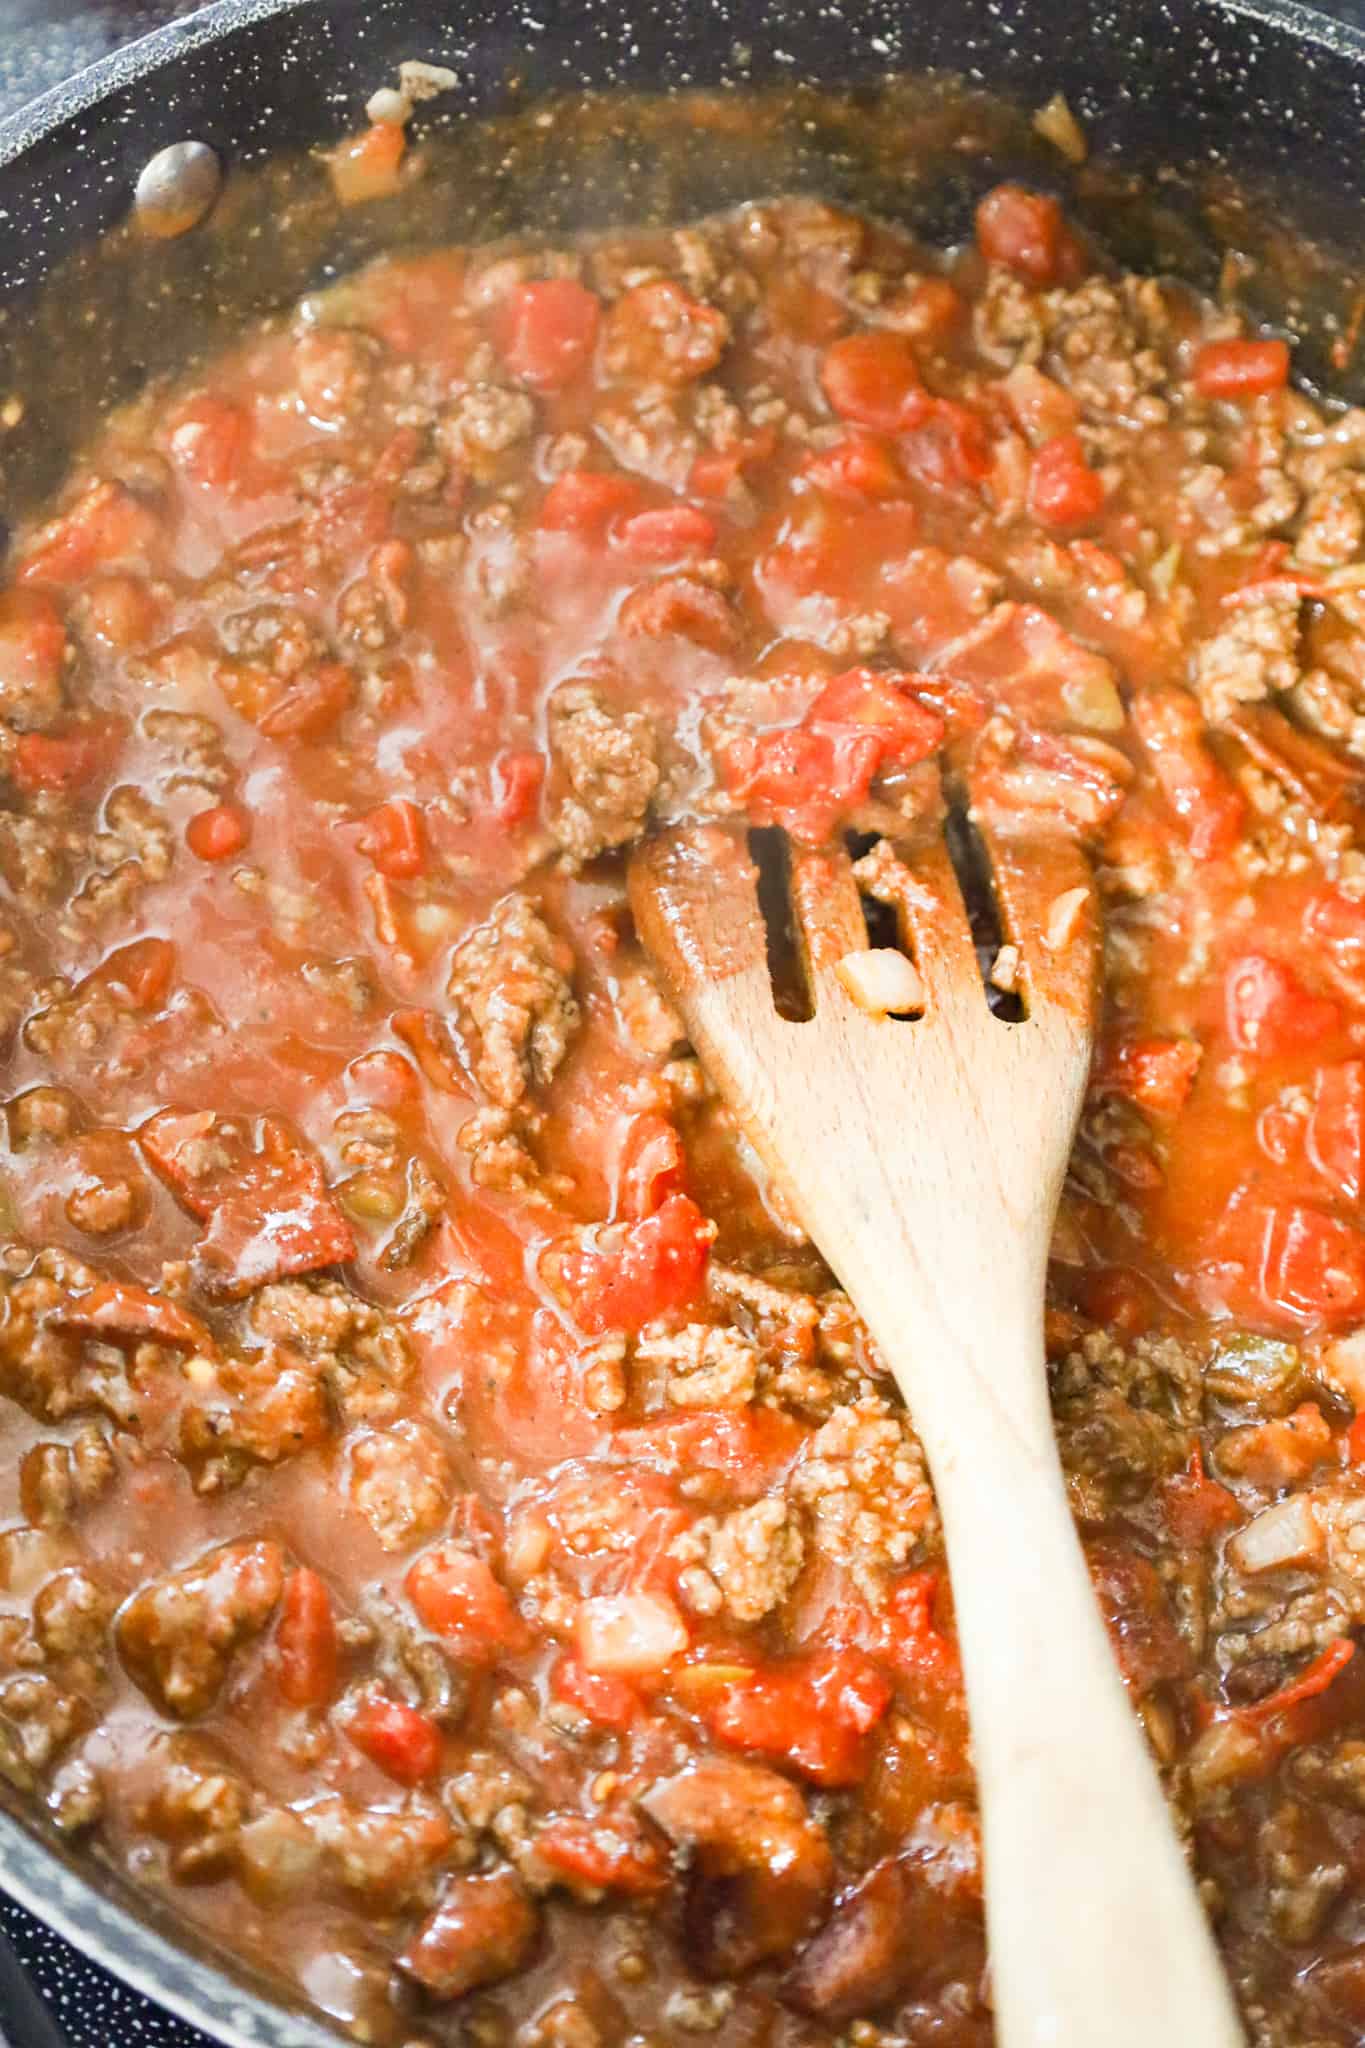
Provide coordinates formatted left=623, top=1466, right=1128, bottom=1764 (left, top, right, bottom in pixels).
left=706, top=1649, right=892, bottom=1786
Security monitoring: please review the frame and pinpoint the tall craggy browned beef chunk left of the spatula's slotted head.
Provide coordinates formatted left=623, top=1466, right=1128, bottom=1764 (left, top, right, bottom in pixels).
left=448, top=895, right=579, bottom=1110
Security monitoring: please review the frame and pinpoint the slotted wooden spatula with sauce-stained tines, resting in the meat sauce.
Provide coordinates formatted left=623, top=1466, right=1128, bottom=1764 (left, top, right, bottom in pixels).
left=630, top=825, right=1244, bottom=2048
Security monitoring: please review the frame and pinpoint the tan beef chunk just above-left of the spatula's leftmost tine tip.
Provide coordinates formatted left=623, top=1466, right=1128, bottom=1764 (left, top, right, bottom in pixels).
left=548, top=682, right=659, bottom=864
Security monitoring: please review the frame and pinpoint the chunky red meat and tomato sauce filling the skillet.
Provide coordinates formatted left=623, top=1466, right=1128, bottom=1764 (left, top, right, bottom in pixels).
left=0, top=167, right=1365, bottom=2048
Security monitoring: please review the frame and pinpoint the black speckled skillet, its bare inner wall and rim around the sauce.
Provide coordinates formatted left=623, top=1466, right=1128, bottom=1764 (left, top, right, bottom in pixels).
left=0, top=0, right=1365, bottom=2048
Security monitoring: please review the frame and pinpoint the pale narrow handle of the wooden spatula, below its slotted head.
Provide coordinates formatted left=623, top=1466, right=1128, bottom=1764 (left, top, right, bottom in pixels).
left=876, top=1315, right=1244, bottom=2048
